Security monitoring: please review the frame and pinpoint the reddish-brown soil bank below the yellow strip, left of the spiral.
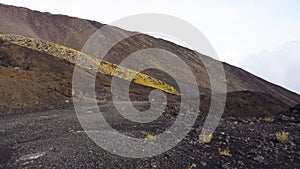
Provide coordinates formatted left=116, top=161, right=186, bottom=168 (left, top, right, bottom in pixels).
left=0, top=42, right=73, bottom=109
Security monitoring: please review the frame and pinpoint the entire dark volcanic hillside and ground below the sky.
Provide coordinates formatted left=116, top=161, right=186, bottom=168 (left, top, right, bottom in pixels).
left=0, top=4, right=300, bottom=169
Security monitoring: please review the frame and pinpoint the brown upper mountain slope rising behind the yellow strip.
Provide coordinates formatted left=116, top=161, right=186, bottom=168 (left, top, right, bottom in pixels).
left=0, top=4, right=300, bottom=116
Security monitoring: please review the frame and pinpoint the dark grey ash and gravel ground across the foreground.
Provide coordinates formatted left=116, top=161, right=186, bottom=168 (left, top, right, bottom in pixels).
left=0, top=105, right=300, bottom=168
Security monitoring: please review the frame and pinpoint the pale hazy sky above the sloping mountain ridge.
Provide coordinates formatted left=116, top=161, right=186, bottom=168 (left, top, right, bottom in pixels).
left=0, top=0, right=300, bottom=93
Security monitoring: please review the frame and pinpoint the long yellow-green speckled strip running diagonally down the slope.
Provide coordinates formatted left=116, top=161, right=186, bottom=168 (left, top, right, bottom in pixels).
left=0, top=34, right=180, bottom=95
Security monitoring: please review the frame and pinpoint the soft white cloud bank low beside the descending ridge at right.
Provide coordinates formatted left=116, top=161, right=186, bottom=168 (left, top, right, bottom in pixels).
left=239, top=41, right=300, bottom=93
